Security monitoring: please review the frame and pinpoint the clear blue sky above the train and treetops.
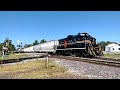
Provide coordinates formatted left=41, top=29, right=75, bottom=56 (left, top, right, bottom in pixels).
left=0, top=11, right=120, bottom=45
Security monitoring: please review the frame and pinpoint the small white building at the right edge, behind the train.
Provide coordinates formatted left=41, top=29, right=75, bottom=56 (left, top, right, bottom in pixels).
left=105, top=43, right=120, bottom=53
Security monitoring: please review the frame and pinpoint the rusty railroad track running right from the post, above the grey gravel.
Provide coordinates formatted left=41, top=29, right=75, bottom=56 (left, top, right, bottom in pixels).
left=50, top=55, right=120, bottom=67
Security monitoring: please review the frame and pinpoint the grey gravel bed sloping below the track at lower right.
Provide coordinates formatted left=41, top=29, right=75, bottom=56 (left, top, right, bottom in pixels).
left=51, top=58, right=120, bottom=79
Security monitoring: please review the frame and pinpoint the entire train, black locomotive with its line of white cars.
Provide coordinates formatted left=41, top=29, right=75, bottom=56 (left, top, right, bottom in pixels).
left=23, top=33, right=103, bottom=57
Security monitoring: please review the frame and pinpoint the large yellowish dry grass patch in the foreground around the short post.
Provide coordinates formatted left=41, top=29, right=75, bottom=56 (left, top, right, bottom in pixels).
left=0, top=60, right=72, bottom=79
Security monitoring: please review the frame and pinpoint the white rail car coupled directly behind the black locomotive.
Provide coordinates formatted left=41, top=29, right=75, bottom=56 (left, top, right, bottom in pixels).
left=33, top=40, right=59, bottom=52
